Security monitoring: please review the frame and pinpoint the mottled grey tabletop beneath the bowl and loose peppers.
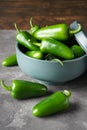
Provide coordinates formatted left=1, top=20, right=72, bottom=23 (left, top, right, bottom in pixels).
left=0, top=30, right=87, bottom=130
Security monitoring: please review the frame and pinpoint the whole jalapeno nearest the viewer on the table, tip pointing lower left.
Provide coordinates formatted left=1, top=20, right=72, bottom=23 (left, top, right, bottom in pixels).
left=32, top=90, right=71, bottom=117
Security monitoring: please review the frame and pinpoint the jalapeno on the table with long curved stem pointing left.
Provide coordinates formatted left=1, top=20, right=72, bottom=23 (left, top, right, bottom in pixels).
left=1, top=80, right=47, bottom=99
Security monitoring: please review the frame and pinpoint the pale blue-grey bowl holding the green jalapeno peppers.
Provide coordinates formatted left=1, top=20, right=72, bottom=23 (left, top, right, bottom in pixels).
left=16, top=43, right=87, bottom=83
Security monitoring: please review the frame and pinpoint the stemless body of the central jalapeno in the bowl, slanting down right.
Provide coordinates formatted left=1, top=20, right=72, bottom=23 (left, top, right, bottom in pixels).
left=40, top=38, right=74, bottom=60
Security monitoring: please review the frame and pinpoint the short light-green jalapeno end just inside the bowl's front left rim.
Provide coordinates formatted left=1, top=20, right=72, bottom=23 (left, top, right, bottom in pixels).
left=25, top=51, right=43, bottom=59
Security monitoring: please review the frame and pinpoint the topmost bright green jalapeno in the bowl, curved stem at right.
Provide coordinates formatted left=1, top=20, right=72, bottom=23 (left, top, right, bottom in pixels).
left=33, top=24, right=81, bottom=41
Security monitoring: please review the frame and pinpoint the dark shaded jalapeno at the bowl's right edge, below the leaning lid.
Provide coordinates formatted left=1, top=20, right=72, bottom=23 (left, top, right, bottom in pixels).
left=71, top=44, right=85, bottom=58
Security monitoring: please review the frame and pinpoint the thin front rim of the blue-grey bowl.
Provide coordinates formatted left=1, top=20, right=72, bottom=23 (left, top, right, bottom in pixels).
left=16, top=43, right=87, bottom=64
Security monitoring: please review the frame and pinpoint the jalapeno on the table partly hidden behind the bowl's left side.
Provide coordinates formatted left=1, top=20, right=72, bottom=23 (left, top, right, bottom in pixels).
left=2, top=54, right=17, bottom=67
